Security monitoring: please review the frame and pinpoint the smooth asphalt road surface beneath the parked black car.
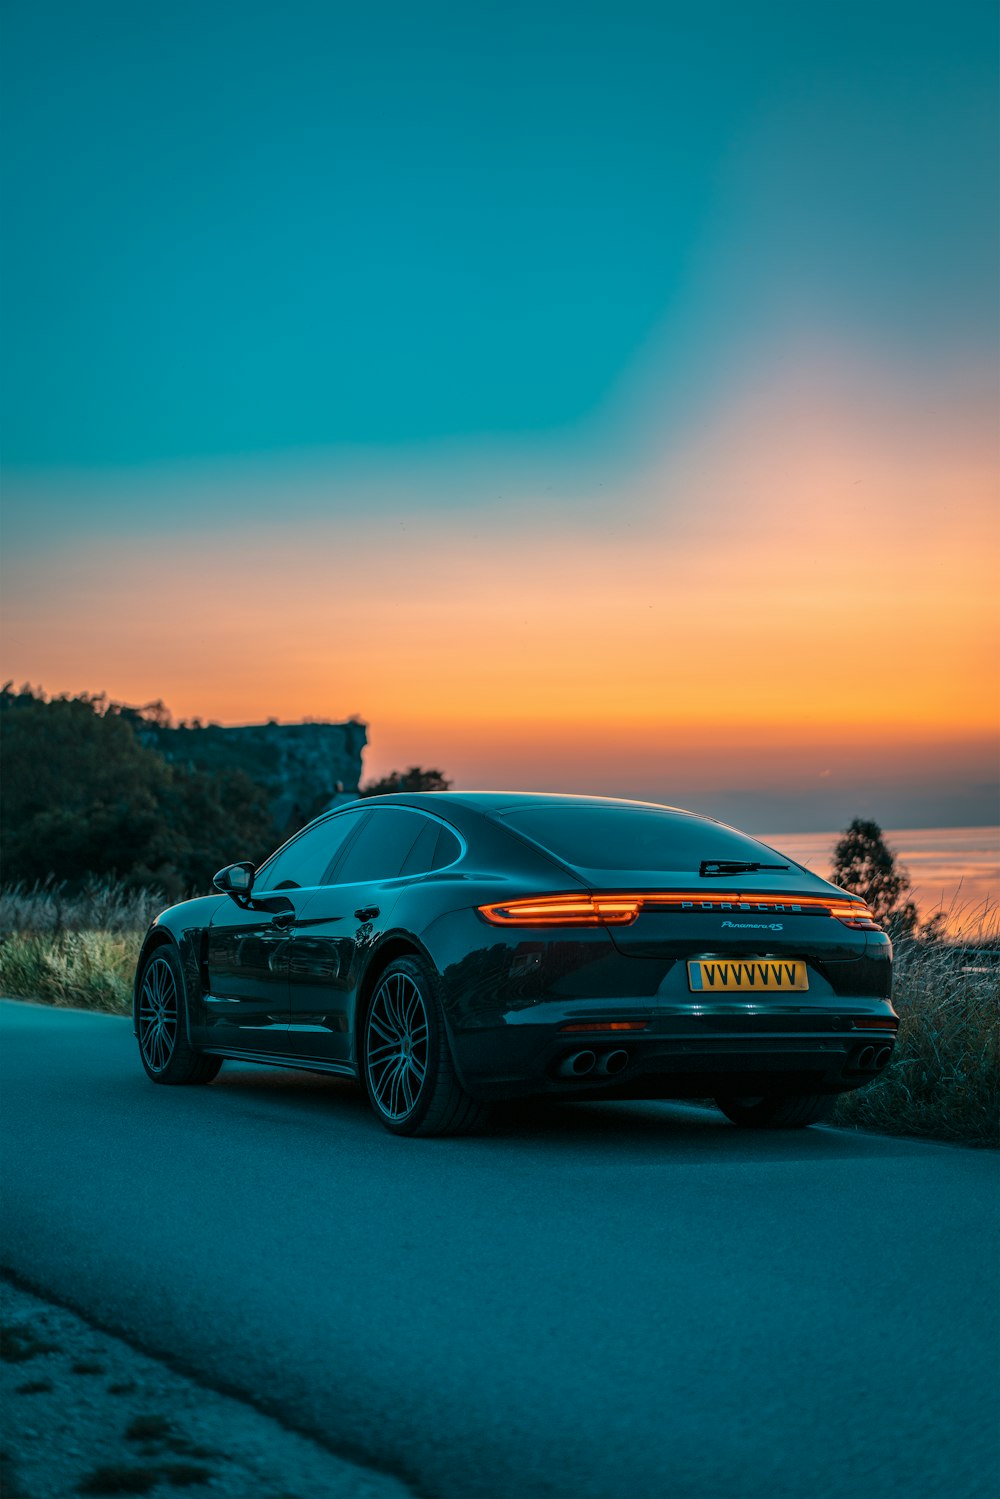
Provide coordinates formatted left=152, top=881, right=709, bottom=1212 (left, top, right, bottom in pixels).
left=0, top=1001, right=1000, bottom=1499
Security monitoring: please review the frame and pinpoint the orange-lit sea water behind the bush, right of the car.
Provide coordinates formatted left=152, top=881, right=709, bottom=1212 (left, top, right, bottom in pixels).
left=759, top=827, right=1000, bottom=941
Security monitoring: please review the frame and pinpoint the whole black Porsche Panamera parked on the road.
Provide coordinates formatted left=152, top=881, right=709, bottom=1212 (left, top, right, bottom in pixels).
left=133, top=791, right=898, bottom=1135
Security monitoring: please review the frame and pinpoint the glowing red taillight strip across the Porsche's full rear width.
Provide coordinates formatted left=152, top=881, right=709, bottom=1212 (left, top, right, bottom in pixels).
left=478, top=890, right=880, bottom=931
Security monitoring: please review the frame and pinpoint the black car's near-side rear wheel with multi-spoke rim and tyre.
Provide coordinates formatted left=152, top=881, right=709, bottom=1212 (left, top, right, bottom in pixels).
left=360, top=958, right=489, bottom=1135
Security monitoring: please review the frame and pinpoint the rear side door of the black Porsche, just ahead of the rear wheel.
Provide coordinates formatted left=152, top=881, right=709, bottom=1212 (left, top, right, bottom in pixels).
left=281, top=806, right=441, bottom=1063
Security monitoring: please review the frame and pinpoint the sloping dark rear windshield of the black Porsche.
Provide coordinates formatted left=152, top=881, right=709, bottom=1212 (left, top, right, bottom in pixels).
left=499, top=806, right=798, bottom=874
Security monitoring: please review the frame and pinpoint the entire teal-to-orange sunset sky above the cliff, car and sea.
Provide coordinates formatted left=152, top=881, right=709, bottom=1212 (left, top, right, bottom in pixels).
left=0, top=0, right=1000, bottom=830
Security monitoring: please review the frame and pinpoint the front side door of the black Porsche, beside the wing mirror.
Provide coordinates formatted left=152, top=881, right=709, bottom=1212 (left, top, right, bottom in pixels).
left=205, top=811, right=366, bottom=1054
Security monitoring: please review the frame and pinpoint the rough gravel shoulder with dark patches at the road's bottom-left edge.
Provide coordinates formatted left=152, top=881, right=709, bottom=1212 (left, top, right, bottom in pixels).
left=0, top=1280, right=412, bottom=1499
